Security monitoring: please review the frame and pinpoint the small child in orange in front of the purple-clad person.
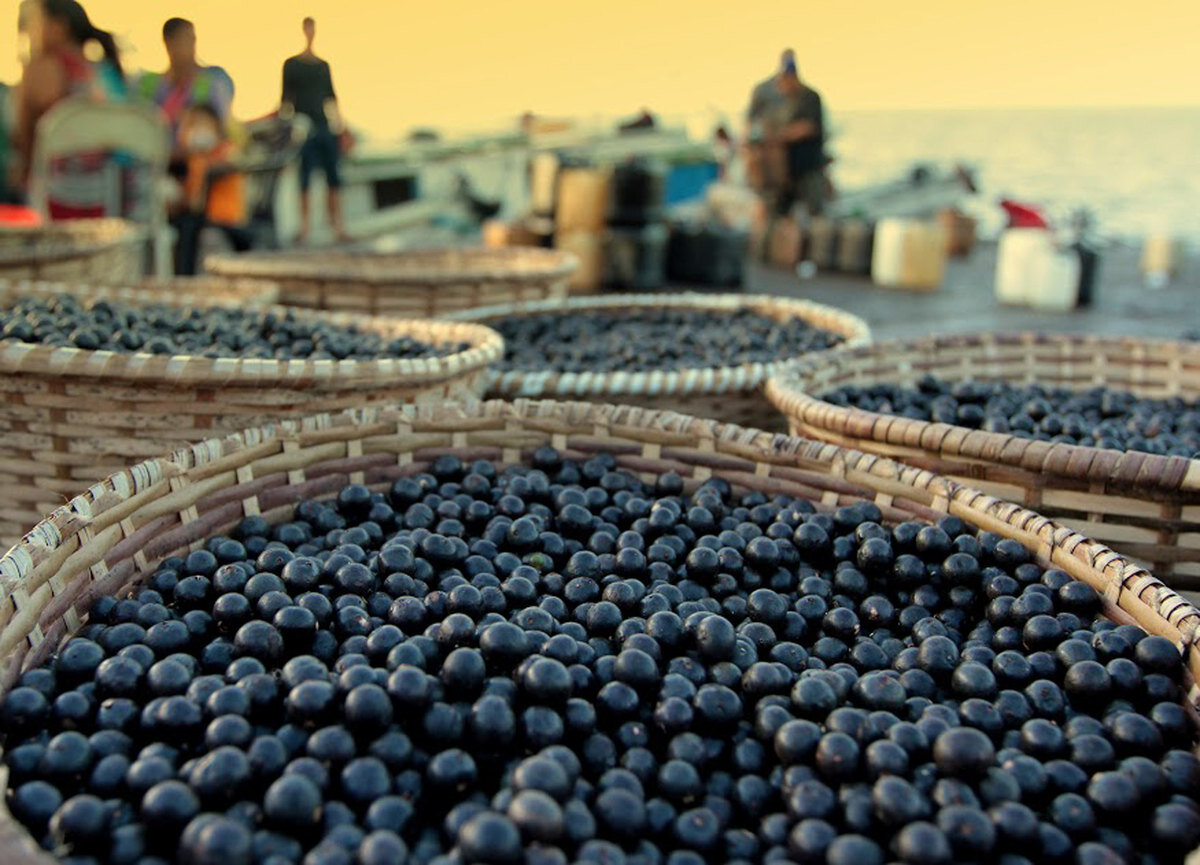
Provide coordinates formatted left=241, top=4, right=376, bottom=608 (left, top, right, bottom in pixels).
left=175, top=104, right=246, bottom=275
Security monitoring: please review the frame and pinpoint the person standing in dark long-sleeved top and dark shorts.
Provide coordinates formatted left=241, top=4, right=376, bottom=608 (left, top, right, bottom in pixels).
left=280, top=18, right=348, bottom=244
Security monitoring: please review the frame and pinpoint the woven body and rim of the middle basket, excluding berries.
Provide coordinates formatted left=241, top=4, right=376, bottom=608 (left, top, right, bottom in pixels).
left=450, top=293, right=871, bottom=432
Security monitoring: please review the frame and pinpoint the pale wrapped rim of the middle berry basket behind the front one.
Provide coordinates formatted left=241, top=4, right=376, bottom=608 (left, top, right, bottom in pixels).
left=443, top=292, right=871, bottom=398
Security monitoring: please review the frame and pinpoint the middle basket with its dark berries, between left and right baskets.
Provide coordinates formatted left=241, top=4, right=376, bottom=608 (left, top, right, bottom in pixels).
left=454, top=293, right=871, bottom=430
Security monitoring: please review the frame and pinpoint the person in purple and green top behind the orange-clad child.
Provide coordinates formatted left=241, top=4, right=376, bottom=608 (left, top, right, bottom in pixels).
left=136, top=18, right=233, bottom=171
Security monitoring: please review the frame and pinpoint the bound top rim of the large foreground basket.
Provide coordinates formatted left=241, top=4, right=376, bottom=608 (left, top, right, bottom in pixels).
left=0, top=400, right=1200, bottom=652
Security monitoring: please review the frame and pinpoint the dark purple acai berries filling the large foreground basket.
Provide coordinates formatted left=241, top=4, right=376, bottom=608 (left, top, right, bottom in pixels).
left=0, top=447, right=1200, bottom=865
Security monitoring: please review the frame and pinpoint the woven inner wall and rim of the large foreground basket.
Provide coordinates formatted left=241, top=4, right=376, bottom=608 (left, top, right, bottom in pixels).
left=0, top=401, right=1200, bottom=864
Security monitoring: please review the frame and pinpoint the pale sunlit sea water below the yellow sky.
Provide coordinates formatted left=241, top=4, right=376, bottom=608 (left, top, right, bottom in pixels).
left=829, top=106, right=1200, bottom=245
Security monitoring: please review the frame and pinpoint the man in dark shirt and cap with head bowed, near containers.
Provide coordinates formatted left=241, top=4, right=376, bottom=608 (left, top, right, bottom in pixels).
left=768, top=62, right=827, bottom=216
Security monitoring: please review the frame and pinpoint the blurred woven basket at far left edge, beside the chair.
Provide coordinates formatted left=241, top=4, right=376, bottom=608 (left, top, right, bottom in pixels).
left=0, top=220, right=146, bottom=283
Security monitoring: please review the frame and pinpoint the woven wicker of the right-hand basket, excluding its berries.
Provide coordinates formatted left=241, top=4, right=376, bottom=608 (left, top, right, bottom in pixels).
left=767, top=334, right=1200, bottom=589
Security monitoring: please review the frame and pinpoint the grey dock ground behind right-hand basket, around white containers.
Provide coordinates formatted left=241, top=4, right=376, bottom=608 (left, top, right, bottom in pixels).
left=745, top=244, right=1200, bottom=340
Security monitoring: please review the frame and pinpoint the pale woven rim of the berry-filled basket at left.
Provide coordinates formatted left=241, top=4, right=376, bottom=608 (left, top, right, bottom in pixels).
left=0, top=275, right=504, bottom=388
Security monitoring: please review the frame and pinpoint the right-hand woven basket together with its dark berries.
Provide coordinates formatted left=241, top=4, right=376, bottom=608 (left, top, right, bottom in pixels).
left=767, top=334, right=1200, bottom=589
